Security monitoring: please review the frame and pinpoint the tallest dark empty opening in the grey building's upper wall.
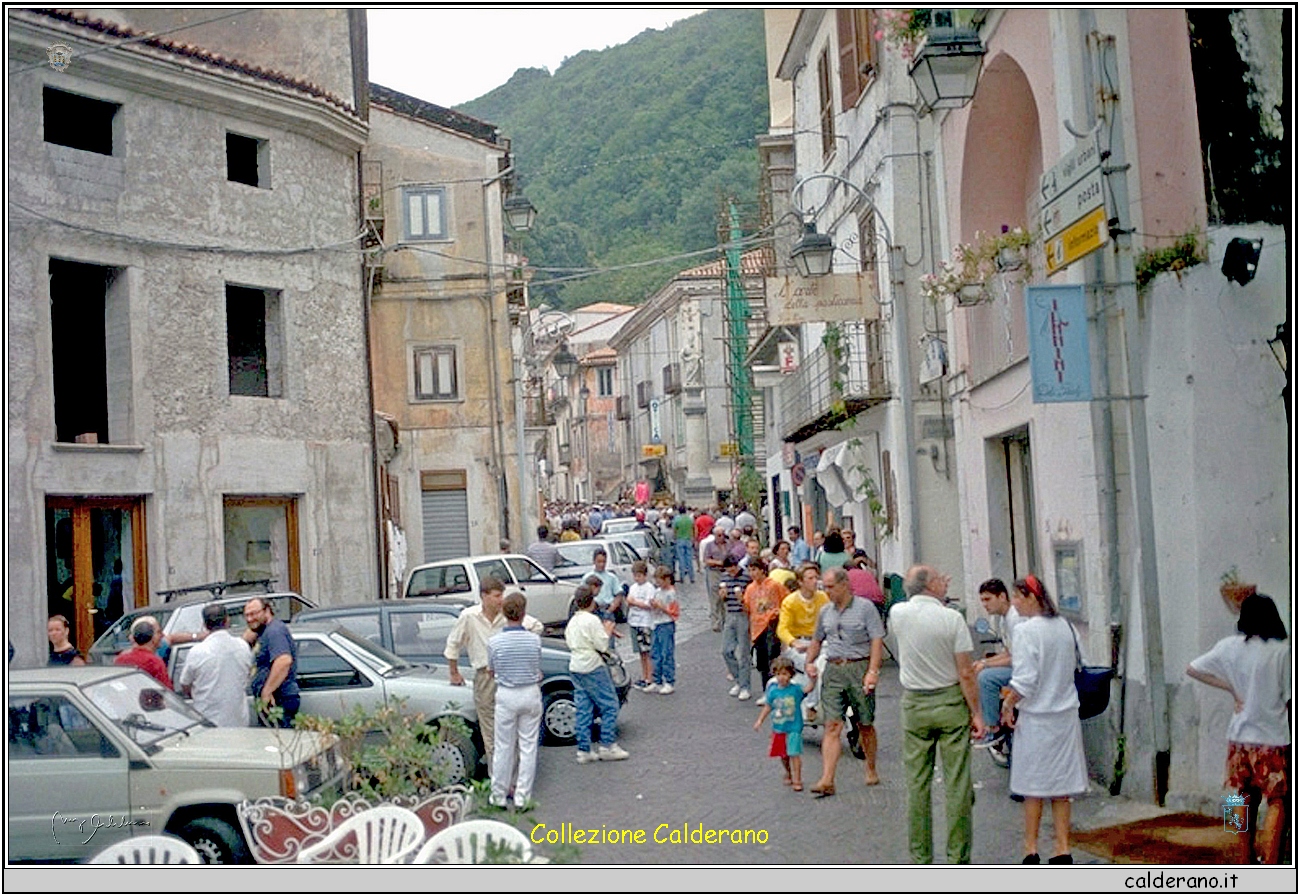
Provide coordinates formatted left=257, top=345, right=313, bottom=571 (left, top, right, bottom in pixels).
left=49, top=259, right=131, bottom=443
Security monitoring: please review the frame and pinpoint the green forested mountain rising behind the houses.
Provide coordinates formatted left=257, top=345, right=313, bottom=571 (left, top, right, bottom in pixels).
left=458, top=9, right=767, bottom=307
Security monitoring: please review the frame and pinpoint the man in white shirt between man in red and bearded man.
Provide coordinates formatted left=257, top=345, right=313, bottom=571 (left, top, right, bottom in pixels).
left=177, top=603, right=252, bottom=728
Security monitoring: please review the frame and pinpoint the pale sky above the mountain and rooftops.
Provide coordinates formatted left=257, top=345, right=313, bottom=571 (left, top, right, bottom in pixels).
left=368, top=7, right=703, bottom=107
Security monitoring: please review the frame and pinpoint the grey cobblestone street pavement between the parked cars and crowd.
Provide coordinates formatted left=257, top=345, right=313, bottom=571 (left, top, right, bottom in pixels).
left=520, top=577, right=1109, bottom=863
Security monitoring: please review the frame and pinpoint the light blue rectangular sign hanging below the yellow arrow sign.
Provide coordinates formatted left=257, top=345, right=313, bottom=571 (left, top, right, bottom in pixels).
left=1024, top=285, right=1092, bottom=403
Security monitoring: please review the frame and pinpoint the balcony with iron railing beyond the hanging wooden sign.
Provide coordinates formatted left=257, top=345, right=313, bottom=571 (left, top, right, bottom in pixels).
left=777, top=320, right=891, bottom=442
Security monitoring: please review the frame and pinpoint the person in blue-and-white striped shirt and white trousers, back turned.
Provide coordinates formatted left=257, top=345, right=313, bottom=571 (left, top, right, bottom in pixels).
left=488, top=592, right=542, bottom=809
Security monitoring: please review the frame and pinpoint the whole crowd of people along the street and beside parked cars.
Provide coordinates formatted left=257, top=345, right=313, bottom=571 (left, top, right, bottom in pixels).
left=47, top=496, right=1291, bottom=863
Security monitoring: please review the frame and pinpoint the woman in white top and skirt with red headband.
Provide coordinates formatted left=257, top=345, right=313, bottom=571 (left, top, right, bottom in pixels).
left=1002, top=575, right=1088, bottom=865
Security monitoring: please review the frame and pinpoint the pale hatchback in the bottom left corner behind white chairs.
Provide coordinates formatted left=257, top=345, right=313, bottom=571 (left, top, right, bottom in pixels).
left=5, top=666, right=346, bottom=863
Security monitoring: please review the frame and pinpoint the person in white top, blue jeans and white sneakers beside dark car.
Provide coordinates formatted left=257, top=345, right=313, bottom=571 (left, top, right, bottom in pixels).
left=564, top=585, right=628, bottom=765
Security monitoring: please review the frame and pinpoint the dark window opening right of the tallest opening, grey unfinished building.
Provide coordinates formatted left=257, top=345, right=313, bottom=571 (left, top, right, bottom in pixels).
left=226, top=283, right=283, bottom=398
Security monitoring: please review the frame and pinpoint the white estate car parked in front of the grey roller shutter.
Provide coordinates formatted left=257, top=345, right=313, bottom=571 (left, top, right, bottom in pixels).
left=402, top=554, right=573, bottom=626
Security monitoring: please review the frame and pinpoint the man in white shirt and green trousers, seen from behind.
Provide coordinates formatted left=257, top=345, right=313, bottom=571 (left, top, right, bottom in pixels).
left=889, top=566, right=984, bottom=865
